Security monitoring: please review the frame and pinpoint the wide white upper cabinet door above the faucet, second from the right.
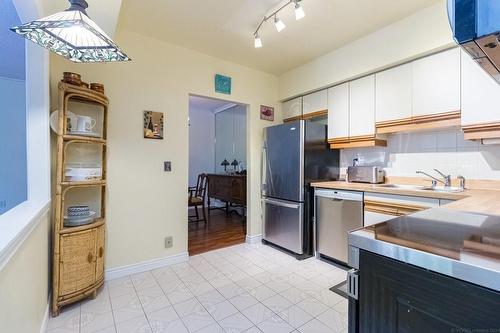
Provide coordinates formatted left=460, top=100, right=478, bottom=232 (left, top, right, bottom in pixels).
left=412, top=48, right=461, bottom=117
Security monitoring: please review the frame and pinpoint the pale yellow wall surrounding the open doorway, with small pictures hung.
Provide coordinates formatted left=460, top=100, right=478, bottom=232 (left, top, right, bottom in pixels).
left=51, top=31, right=281, bottom=269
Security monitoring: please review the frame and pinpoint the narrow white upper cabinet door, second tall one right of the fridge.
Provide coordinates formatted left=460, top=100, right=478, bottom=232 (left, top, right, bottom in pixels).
left=349, top=75, right=375, bottom=137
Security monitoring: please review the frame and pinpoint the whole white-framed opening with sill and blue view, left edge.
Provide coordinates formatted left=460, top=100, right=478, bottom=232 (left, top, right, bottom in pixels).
left=0, top=0, right=50, bottom=270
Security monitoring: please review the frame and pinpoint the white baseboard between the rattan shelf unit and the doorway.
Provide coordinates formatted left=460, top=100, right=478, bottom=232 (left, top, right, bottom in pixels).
left=104, top=252, right=189, bottom=281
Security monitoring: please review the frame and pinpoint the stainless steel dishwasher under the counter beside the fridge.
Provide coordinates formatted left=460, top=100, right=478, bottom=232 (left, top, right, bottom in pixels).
left=315, top=188, right=363, bottom=264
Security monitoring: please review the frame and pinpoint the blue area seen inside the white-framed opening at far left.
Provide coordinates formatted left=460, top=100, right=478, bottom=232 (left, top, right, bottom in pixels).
left=0, top=0, right=28, bottom=215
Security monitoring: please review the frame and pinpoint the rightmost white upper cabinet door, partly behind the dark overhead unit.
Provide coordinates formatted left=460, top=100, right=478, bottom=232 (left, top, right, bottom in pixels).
left=462, top=49, right=500, bottom=126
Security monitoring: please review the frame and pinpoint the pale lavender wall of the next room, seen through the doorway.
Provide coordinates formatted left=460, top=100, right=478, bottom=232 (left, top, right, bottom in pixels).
left=189, top=107, right=215, bottom=186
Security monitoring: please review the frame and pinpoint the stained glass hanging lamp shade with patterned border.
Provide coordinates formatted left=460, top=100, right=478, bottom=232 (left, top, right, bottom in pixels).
left=11, top=0, right=131, bottom=62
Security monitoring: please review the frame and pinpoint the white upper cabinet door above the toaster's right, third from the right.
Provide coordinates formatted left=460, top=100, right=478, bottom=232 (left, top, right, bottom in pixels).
left=375, top=63, right=413, bottom=122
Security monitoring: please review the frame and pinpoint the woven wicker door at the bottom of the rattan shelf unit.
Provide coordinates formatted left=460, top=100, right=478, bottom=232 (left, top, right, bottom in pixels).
left=59, top=229, right=96, bottom=296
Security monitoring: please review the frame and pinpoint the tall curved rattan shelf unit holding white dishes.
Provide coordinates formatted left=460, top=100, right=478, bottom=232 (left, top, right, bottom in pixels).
left=52, top=82, right=109, bottom=316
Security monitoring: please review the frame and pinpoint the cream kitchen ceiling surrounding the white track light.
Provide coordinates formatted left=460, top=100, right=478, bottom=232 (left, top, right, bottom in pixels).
left=119, top=0, right=442, bottom=75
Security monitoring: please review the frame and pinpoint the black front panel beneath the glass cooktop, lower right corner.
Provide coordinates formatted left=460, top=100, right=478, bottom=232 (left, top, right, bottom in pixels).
left=358, top=251, right=500, bottom=333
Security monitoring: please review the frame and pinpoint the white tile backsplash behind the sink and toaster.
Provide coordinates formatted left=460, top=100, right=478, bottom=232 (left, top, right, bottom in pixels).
left=340, top=130, right=500, bottom=179
